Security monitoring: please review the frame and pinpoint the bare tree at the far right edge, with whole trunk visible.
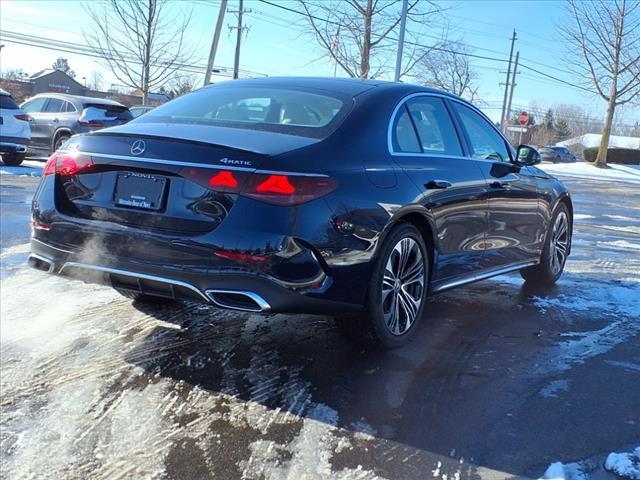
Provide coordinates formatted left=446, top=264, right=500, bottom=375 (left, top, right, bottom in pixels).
left=559, top=0, right=640, bottom=167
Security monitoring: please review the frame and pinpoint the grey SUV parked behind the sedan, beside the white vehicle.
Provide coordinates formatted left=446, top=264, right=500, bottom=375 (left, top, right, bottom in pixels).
left=22, top=93, right=133, bottom=152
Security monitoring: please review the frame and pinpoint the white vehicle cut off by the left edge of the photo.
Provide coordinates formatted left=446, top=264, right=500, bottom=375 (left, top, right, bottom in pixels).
left=0, top=89, right=31, bottom=166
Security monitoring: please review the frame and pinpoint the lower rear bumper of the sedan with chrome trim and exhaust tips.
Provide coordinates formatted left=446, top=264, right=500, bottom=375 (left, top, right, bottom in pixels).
left=29, top=239, right=362, bottom=315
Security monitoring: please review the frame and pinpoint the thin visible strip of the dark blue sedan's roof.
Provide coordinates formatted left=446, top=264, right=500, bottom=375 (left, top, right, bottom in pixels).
left=204, top=77, right=457, bottom=98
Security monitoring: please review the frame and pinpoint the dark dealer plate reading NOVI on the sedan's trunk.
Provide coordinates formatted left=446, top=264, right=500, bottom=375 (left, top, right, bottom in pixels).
left=114, top=172, right=167, bottom=210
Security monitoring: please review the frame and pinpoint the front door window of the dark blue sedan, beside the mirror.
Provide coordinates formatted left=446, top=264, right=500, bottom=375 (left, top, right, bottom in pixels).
left=451, top=102, right=510, bottom=162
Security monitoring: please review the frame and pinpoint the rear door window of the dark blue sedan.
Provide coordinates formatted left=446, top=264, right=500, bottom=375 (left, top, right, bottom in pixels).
left=407, top=97, right=462, bottom=156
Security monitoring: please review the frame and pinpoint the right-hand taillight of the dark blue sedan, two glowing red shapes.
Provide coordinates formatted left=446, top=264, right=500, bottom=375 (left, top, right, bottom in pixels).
left=181, top=168, right=337, bottom=205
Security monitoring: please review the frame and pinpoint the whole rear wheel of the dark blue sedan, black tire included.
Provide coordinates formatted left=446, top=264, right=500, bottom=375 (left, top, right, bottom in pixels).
left=336, top=224, right=430, bottom=350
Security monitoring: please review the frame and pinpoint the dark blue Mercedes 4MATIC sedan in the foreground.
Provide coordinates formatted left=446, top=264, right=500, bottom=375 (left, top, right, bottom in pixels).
left=29, top=78, right=573, bottom=348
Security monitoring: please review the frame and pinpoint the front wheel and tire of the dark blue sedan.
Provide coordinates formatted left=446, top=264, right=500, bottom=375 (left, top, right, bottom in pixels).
left=520, top=203, right=572, bottom=286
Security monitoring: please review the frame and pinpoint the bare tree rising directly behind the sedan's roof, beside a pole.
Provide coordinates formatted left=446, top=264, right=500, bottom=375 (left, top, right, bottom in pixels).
left=297, top=0, right=442, bottom=79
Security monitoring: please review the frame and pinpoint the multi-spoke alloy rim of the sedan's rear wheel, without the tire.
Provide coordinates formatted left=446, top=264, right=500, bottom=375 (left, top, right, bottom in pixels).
left=381, top=237, right=425, bottom=335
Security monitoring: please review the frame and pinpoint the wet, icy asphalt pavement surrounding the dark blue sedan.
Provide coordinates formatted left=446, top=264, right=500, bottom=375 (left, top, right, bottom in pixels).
left=0, top=166, right=640, bottom=480
